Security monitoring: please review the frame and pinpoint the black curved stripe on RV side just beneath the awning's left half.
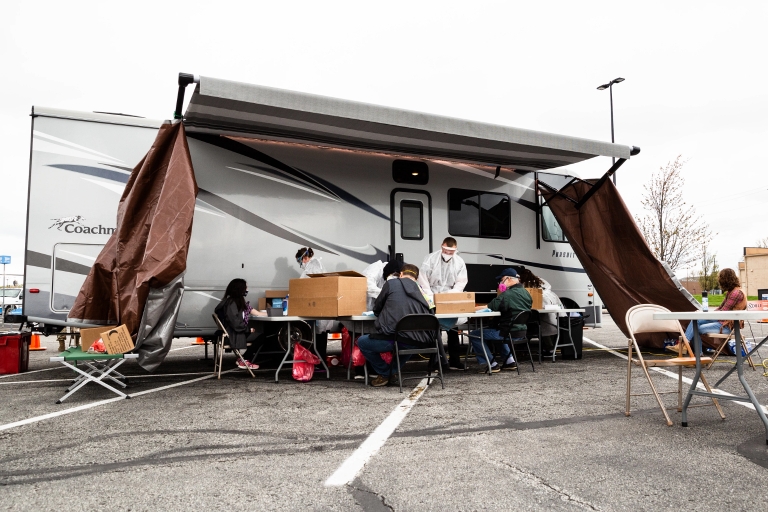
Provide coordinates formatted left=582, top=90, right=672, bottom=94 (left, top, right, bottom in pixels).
left=187, top=133, right=389, bottom=221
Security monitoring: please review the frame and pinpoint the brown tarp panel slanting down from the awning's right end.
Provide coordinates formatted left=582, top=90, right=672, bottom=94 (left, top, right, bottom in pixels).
left=542, top=180, right=696, bottom=346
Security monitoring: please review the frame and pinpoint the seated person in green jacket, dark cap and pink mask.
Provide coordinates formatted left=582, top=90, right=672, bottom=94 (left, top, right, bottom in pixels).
left=469, top=268, right=533, bottom=373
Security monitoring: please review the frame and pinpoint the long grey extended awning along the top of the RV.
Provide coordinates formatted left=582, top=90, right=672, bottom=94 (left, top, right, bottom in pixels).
left=184, top=77, right=631, bottom=171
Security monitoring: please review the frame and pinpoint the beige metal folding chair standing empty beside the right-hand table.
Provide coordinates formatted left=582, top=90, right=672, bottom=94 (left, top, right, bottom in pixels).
left=624, top=304, right=725, bottom=427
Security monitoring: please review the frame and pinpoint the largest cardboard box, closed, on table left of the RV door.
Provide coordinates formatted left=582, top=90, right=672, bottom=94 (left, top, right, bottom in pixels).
left=288, top=270, right=368, bottom=318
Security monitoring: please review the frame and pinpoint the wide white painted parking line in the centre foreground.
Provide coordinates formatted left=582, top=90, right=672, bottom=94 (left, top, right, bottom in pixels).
left=325, top=379, right=428, bottom=487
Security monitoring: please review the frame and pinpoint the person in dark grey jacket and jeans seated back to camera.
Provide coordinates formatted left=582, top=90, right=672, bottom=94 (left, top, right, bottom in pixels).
left=357, top=264, right=430, bottom=387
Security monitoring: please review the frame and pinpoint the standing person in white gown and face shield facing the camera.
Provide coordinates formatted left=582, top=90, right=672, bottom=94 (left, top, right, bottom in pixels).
left=419, top=236, right=468, bottom=370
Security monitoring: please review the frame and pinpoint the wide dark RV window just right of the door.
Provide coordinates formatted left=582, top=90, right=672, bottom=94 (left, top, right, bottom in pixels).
left=448, top=188, right=511, bottom=238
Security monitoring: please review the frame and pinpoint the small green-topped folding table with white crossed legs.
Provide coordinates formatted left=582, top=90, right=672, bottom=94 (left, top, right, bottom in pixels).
left=51, top=346, right=139, bottom=404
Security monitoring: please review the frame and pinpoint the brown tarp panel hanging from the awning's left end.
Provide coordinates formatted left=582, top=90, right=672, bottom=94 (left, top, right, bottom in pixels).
left=68, top=123, right=198, bottom=348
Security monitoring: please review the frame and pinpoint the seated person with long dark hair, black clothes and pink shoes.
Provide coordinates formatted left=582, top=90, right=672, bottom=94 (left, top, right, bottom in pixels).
left=214, top=279, right=267, bottom=370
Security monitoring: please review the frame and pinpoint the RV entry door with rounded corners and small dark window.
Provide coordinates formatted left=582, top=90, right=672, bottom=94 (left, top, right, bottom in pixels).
left=390, top=189, right=432, bottom=265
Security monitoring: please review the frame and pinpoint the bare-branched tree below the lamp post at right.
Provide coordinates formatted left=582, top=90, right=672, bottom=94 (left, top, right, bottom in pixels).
left=635, top=155, right=712, bottom=270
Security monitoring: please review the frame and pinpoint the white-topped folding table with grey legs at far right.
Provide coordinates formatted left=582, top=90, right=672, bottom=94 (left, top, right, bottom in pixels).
left=653, top=311, right=768, bottom=444
